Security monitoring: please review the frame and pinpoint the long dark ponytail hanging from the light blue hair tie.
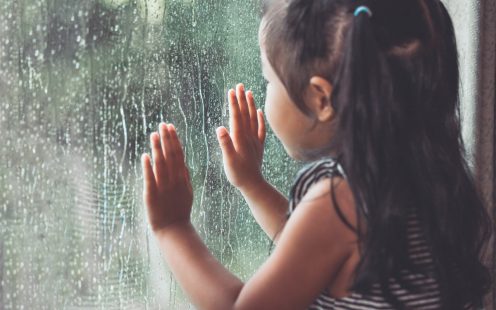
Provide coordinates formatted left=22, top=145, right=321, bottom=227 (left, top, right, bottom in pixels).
left=331, top=4, right=409, bottom=308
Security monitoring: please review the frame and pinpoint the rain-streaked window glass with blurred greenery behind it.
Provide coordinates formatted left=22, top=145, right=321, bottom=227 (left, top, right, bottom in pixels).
left=0, top=0, right=297, bottom=309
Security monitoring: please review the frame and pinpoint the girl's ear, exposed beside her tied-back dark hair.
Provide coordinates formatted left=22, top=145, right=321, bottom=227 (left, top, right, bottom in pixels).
left=307, top=76, right=335, bottom=122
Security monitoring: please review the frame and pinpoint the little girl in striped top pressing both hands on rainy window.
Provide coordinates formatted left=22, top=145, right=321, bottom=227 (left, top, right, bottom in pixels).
left=142, top=0, right=490, bottom=309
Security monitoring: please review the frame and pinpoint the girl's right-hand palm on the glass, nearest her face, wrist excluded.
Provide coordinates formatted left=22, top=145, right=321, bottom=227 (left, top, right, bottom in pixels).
left=216, top=84, right=265, bottom=189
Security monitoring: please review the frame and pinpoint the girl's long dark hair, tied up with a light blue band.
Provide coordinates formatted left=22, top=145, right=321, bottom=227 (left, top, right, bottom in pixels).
left=261, top=0, right=491, bottom=309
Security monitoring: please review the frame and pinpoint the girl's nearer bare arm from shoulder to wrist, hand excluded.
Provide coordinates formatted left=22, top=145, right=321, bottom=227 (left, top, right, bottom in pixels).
left=151, top=176, right=354, bottom=310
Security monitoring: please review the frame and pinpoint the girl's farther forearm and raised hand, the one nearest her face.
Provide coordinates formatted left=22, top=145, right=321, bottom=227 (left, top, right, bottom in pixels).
left=217, top=84, right=288, bottom=243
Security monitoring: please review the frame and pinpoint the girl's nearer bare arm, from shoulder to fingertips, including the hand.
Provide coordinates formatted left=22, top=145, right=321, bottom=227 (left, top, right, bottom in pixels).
left=142, top=124, right=356, bottom=310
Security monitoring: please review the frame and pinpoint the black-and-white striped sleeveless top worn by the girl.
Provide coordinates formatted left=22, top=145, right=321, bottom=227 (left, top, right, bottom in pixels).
left=288, top=157, right=470, bottom=310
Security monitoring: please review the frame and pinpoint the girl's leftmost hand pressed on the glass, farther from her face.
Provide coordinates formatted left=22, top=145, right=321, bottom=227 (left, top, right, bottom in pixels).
left=141, top=123, right=193, bottom=233
